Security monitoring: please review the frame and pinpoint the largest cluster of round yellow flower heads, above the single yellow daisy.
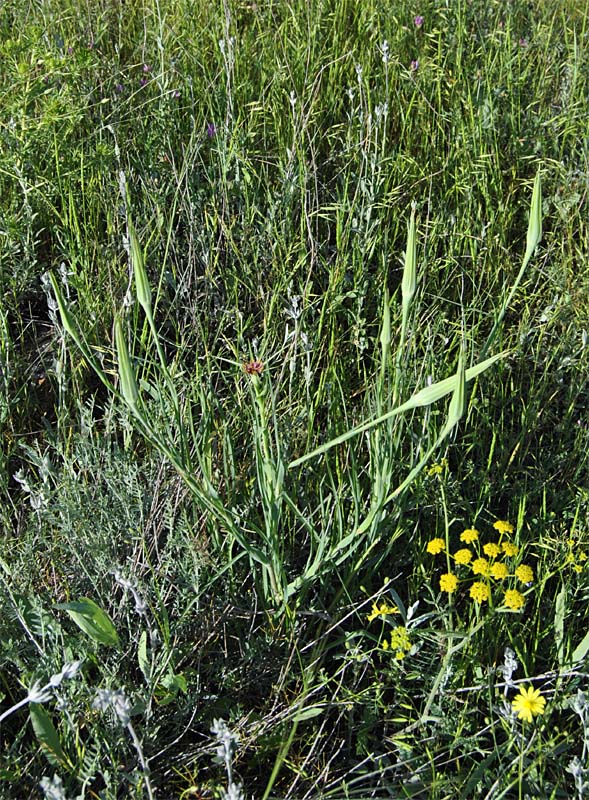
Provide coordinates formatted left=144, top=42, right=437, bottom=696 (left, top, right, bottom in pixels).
left=426, top=520, right=534, bottom=611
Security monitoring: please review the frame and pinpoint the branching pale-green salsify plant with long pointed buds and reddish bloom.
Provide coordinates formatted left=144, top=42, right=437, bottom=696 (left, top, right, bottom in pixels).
left=49, top=171, right=542, bottom=611
